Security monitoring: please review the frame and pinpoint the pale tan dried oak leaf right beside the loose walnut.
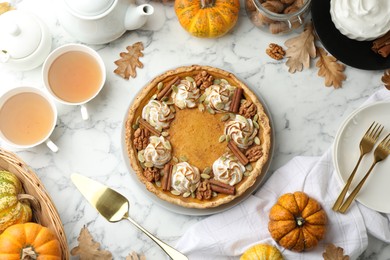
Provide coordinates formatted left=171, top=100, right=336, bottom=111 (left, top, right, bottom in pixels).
left=284, top=23, right=316, bottom=73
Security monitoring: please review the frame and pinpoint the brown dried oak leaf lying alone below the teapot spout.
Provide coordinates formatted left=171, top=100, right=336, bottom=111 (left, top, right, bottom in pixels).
left=114, top=42, right=144, bottom=79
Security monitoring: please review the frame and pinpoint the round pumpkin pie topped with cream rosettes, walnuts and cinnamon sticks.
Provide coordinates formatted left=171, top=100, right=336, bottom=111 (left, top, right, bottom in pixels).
left=125, top=65, right=272, bottom=208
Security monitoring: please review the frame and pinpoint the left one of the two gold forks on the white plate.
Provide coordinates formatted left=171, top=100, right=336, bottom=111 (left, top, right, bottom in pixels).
left=332, top=122, right=383, bottom=211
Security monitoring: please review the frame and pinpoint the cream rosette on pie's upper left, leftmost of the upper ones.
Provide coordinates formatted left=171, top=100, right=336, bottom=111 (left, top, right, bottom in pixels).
left=142, top=99, right=175, bottom=131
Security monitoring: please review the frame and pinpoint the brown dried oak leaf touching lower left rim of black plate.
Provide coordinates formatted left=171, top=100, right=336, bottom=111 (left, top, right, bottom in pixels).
left=316, top=47, right=347, bottom=88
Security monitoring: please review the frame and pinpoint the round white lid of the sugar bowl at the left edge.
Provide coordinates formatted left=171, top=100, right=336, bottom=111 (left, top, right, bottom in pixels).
left=0, top=10, right=42, bottom=59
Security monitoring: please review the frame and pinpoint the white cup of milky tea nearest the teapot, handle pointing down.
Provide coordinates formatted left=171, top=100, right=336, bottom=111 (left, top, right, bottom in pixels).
left=43, top=44, right=106, bottom=120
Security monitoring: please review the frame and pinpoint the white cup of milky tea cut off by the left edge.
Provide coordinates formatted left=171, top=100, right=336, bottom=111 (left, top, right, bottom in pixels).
left=0, top=87, right=58, bottom=152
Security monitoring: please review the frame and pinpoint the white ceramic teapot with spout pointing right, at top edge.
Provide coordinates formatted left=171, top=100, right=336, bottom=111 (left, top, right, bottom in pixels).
left=58, top=0, right=154, bottom=44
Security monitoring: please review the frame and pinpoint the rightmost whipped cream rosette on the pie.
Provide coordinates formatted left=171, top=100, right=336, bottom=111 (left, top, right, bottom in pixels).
left=225, top=115, right=257, bottom=149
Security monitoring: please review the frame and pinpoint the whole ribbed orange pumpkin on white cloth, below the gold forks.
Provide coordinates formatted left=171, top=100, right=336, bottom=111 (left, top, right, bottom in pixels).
left=268, top=192, right=327, bottom=252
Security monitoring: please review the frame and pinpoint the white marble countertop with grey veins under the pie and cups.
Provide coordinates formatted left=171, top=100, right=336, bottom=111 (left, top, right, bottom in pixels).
left=0, top=0, right=390, bottom=259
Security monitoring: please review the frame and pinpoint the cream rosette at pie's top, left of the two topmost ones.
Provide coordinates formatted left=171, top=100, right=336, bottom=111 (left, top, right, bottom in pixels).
left=172, top=80, right=200, bottom=109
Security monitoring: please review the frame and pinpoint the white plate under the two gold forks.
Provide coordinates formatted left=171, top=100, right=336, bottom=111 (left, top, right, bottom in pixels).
left=333, top=102, right=390, bottom=213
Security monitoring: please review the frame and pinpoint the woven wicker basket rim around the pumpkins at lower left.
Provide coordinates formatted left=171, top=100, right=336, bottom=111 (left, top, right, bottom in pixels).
left=0, top=148, right=70, bottom=260
